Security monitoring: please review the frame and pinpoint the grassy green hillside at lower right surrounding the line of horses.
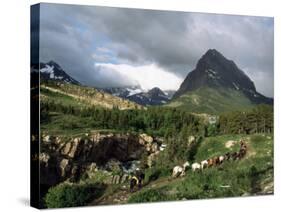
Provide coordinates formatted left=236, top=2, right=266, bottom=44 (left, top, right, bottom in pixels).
left=128, top=134, right=274, bottom=203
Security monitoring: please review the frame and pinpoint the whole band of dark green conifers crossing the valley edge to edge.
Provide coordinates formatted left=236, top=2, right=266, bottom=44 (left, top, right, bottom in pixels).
left=40, top=101, right=274, bottom=138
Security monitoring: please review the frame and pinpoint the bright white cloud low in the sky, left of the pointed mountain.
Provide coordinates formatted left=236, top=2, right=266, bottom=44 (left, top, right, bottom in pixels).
left=95, top=63, right=183, bottom=90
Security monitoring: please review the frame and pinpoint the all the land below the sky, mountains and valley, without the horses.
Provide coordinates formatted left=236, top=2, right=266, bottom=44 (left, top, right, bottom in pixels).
left=36, top=50, right=274, bottom=208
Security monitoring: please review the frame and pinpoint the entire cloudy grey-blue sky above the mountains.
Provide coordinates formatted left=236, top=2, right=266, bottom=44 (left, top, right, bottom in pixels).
left=40, top=4, right=274, bottom=97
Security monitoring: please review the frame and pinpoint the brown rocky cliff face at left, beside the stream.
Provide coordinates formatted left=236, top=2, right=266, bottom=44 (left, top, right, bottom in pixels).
left=39, top=133, right=161, bottom=186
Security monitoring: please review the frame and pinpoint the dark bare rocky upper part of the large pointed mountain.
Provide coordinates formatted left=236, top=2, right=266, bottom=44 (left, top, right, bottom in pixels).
left=173, top=49, right=271, bottom=103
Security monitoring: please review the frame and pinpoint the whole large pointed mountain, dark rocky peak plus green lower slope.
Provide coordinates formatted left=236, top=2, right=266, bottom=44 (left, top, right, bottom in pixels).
left=167, top=49, right=273, bottom=113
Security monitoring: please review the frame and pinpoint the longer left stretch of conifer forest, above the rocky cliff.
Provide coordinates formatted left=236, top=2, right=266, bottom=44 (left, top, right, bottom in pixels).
left=40, top=101, right=203, bottom=137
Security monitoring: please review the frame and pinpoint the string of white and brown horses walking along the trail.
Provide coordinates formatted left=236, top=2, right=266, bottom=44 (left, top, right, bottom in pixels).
left=172, top=139, right=248, bottom=178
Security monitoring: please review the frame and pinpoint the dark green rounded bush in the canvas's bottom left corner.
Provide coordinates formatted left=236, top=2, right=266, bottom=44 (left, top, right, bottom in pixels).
left=45, top=183, right=103, bottom=208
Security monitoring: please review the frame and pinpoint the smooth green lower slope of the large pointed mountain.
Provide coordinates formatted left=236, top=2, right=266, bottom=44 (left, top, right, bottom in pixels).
left=167, top=87, right=254, bottom=114
